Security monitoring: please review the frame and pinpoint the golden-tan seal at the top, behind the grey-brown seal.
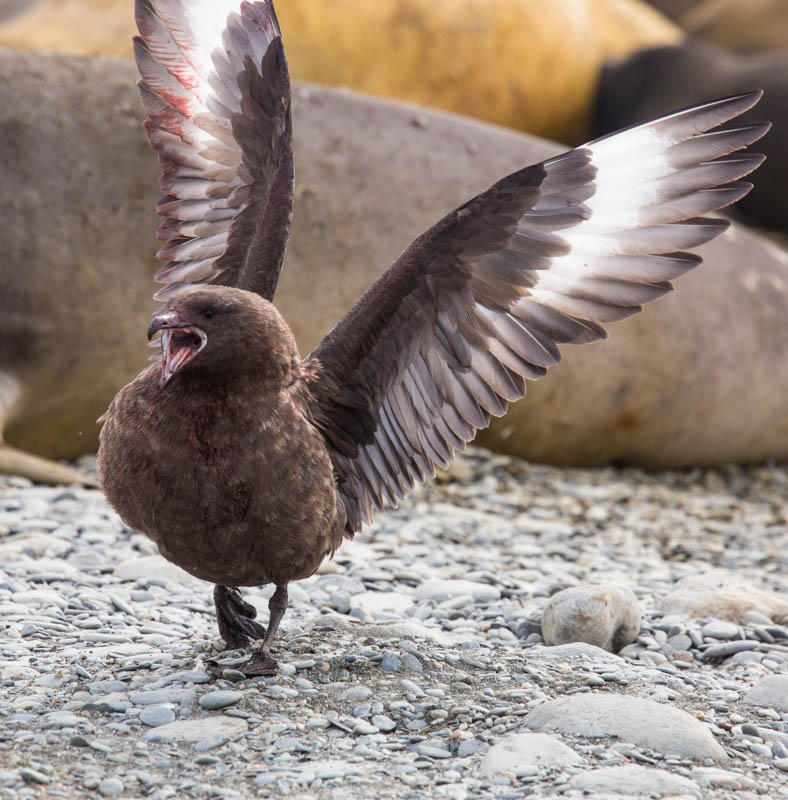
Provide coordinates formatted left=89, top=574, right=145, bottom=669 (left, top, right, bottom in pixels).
left=0, top=0, right=681, bottom=143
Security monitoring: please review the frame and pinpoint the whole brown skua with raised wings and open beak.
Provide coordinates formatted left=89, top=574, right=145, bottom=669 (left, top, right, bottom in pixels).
left=99, top=0, right=768, bottom=674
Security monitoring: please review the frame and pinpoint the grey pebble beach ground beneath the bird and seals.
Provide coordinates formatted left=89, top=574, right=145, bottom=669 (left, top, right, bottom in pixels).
left=0, top=450, right=788, bottom=800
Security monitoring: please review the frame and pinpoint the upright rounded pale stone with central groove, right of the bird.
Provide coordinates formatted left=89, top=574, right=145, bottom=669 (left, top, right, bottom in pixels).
left=542, top=585, right=640, bottom=653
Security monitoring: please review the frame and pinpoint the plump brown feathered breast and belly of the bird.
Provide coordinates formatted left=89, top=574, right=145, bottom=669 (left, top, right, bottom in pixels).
left=99, top=373, right=336, bottom=586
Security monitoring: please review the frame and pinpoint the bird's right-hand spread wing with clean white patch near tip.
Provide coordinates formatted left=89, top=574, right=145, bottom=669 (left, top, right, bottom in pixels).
left=305, top=92, right=769, bottom=535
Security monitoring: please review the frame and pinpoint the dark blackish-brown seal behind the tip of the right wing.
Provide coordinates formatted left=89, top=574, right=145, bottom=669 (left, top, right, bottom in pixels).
left=594, top=41, right=788, bottom=232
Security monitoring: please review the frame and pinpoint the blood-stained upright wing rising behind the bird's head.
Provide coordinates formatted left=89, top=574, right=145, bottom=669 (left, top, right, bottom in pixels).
left=134, top=0, right=293, bottom=300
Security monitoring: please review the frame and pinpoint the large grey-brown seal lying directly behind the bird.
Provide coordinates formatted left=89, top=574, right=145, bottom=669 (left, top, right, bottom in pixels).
left=0, top=52, right=788, bottom=476
